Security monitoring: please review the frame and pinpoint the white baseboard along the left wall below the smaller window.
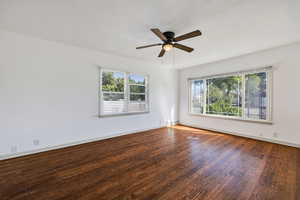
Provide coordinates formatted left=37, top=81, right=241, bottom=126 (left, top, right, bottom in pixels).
left=0, top=126, right=165, bottom=160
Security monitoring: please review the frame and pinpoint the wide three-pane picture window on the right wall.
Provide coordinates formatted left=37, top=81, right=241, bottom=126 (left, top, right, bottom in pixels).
left=189, top=67, right=272, bottom=122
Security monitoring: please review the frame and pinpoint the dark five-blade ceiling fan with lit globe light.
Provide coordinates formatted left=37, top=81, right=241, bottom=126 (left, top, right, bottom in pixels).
left=136, top=28, right=202, bottom=57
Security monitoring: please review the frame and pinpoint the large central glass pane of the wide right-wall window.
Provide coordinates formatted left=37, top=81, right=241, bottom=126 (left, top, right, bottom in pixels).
left=206, top=76, right=242, bottom=116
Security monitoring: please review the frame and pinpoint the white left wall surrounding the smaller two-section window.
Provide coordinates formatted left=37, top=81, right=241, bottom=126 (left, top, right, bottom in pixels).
left=0, top=31, right=178, bottom=157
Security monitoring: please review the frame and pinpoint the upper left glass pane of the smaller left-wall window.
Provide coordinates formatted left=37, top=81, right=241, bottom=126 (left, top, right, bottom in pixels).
left=102, top=71, right=125, bottom=92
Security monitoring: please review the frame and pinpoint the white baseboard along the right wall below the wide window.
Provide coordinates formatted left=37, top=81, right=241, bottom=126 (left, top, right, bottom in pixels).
left=179, top=122, right=300, bottom=148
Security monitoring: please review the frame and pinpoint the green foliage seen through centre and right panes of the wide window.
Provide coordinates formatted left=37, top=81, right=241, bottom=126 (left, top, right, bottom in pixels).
left=206, top=73, right=266, bottom=116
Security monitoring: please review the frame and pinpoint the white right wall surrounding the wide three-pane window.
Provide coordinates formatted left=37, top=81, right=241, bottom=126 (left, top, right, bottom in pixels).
left=179, top=43, right=300, bottom=145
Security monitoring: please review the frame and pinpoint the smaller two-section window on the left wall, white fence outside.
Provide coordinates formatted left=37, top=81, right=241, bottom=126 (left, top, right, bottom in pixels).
left=100, top=69, right=148, bottom=116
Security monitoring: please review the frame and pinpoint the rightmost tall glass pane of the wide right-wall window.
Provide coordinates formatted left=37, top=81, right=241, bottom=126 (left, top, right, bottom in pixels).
left=245, top=72, right=267, bottom=120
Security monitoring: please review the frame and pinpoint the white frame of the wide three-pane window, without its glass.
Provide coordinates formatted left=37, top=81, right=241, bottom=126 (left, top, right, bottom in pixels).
left=188, top=66, right=273, bottom=124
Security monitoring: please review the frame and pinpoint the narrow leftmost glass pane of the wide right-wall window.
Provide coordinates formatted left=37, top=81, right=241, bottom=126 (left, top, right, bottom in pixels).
left=191, top=80, right=205, bottom=113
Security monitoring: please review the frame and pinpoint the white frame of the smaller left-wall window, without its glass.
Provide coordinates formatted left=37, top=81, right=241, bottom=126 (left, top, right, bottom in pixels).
left=99, top=68, right=150, bottom=117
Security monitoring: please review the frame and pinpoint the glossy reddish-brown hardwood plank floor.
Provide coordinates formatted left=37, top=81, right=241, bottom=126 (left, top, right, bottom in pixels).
left=0, top=126, right=300, bottom=200
